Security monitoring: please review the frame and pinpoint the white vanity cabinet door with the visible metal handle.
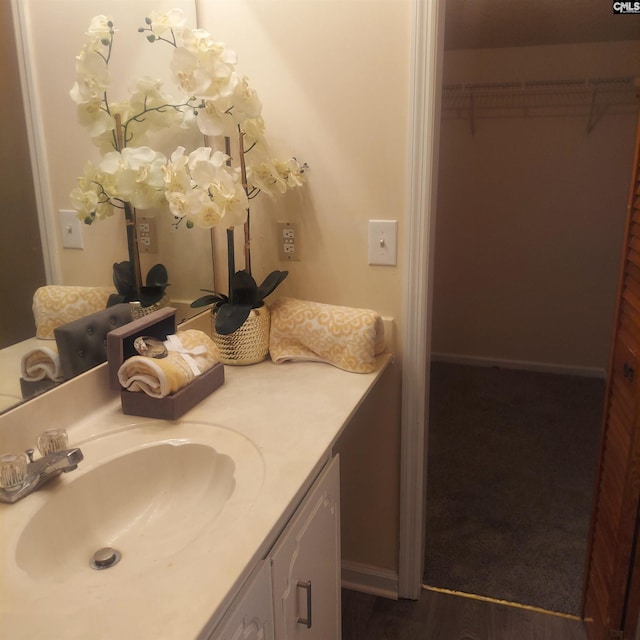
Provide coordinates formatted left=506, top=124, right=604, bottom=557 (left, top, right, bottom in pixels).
left=271, top=456, right=341, bottom=640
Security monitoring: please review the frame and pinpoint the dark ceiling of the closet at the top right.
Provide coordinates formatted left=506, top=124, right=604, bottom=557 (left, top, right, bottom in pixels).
left=445, top=0, right=640, bottom=49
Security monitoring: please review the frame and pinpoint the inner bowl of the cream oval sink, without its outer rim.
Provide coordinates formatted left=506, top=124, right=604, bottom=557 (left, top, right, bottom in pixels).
left=16, top=441, right=235, bottom=581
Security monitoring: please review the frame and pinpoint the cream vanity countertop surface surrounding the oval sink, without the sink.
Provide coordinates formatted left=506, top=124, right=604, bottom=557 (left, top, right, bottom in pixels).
left=0, top=355, right=390, bottom=640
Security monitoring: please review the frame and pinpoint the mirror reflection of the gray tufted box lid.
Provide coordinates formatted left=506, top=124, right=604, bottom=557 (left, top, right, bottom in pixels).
left=54, top=303, right=131, bottom=379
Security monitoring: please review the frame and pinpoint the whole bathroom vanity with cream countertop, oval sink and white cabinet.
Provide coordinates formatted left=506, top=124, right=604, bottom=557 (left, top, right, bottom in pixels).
left=0, top=342, right=390, bottom=640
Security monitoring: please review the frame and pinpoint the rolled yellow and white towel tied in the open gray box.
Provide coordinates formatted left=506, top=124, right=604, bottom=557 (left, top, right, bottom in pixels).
left=118, top=329, right=218, bottom=398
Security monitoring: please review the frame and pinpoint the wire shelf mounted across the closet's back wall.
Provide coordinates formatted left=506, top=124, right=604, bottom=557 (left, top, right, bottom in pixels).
left=442, top=77, right=640, bottom=133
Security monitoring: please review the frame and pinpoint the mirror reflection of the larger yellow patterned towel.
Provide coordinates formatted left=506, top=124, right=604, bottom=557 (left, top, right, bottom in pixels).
left=33, top=285, right=115, bottom=340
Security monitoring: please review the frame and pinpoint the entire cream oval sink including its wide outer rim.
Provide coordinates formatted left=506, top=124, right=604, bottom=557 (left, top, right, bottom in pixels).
left=0, top=422, right=264, bottom=588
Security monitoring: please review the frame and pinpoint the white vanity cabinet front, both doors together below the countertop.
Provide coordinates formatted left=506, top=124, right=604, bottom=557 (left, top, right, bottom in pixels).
left=209, top=456, right=341, bottom=640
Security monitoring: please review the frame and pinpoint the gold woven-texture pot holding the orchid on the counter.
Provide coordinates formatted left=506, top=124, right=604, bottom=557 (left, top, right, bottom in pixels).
left=211, top=304, right=271, bottom=365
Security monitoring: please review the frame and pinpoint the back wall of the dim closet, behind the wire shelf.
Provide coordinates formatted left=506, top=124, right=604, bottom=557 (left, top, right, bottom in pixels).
left=433, top=42, right=640, bottom=370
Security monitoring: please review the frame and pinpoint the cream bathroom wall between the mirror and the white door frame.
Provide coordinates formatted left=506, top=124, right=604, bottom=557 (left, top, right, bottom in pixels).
left=198, top=0, right=411, bottom=571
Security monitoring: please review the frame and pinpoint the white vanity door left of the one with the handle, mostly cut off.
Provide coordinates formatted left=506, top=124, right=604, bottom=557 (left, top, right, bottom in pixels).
left=209, top=561, right=274, bottom=640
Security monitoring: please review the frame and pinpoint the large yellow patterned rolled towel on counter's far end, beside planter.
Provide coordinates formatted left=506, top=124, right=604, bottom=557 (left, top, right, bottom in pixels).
left=269, top=298, right=384, bottom=373
